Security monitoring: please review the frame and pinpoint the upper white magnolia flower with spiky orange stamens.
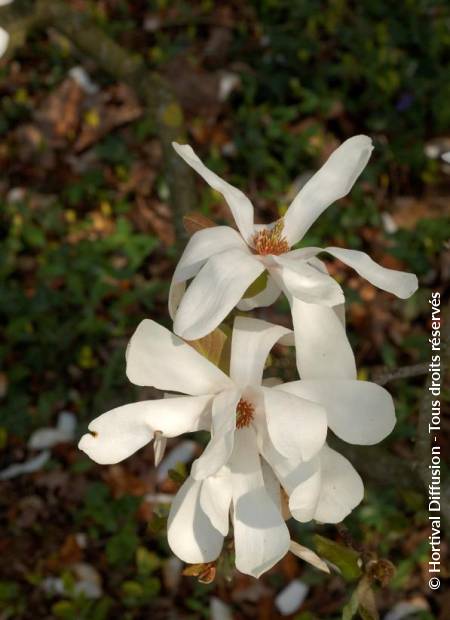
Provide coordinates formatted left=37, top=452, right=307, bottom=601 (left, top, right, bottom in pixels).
left=169, top=135, right=417, bottom=345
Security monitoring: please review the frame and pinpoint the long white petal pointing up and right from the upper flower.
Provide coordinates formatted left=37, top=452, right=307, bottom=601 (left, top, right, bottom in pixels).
left=284, top=136, right=373, bottom=246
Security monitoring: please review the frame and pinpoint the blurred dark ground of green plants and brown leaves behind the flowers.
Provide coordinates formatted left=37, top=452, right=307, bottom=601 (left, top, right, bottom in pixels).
left=0, top=0, right=450, bottom=620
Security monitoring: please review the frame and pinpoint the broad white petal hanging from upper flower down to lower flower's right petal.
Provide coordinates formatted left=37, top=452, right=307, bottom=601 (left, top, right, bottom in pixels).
left=291, top=298, right=356, bottom=379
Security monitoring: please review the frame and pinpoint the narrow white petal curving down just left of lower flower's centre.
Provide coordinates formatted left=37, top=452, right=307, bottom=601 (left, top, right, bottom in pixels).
left=191, top=390, right=241, bottom=480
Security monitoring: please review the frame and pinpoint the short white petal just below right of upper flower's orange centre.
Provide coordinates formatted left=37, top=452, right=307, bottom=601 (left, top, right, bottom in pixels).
left=268, top=253, right=345, bottom=306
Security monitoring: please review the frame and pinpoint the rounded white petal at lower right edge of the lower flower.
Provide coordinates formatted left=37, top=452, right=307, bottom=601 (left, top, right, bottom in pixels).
left=314, top=446, right=364, bottom=523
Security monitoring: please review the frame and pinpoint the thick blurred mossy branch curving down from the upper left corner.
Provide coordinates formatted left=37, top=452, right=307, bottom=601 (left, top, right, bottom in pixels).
left=0, top=0, right=195, bottom=244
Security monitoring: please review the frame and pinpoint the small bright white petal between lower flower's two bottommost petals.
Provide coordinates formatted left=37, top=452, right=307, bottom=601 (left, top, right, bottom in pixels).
left=200, top=470, right=232, bottom=536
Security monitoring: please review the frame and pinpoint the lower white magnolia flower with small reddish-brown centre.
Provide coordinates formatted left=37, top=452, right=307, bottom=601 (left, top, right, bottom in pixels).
left=79, top=317, right=395, bottom=576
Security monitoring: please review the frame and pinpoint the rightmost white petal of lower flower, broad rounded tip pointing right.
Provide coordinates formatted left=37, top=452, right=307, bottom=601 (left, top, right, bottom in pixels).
left=277, top=379, right=395, bottom=446
